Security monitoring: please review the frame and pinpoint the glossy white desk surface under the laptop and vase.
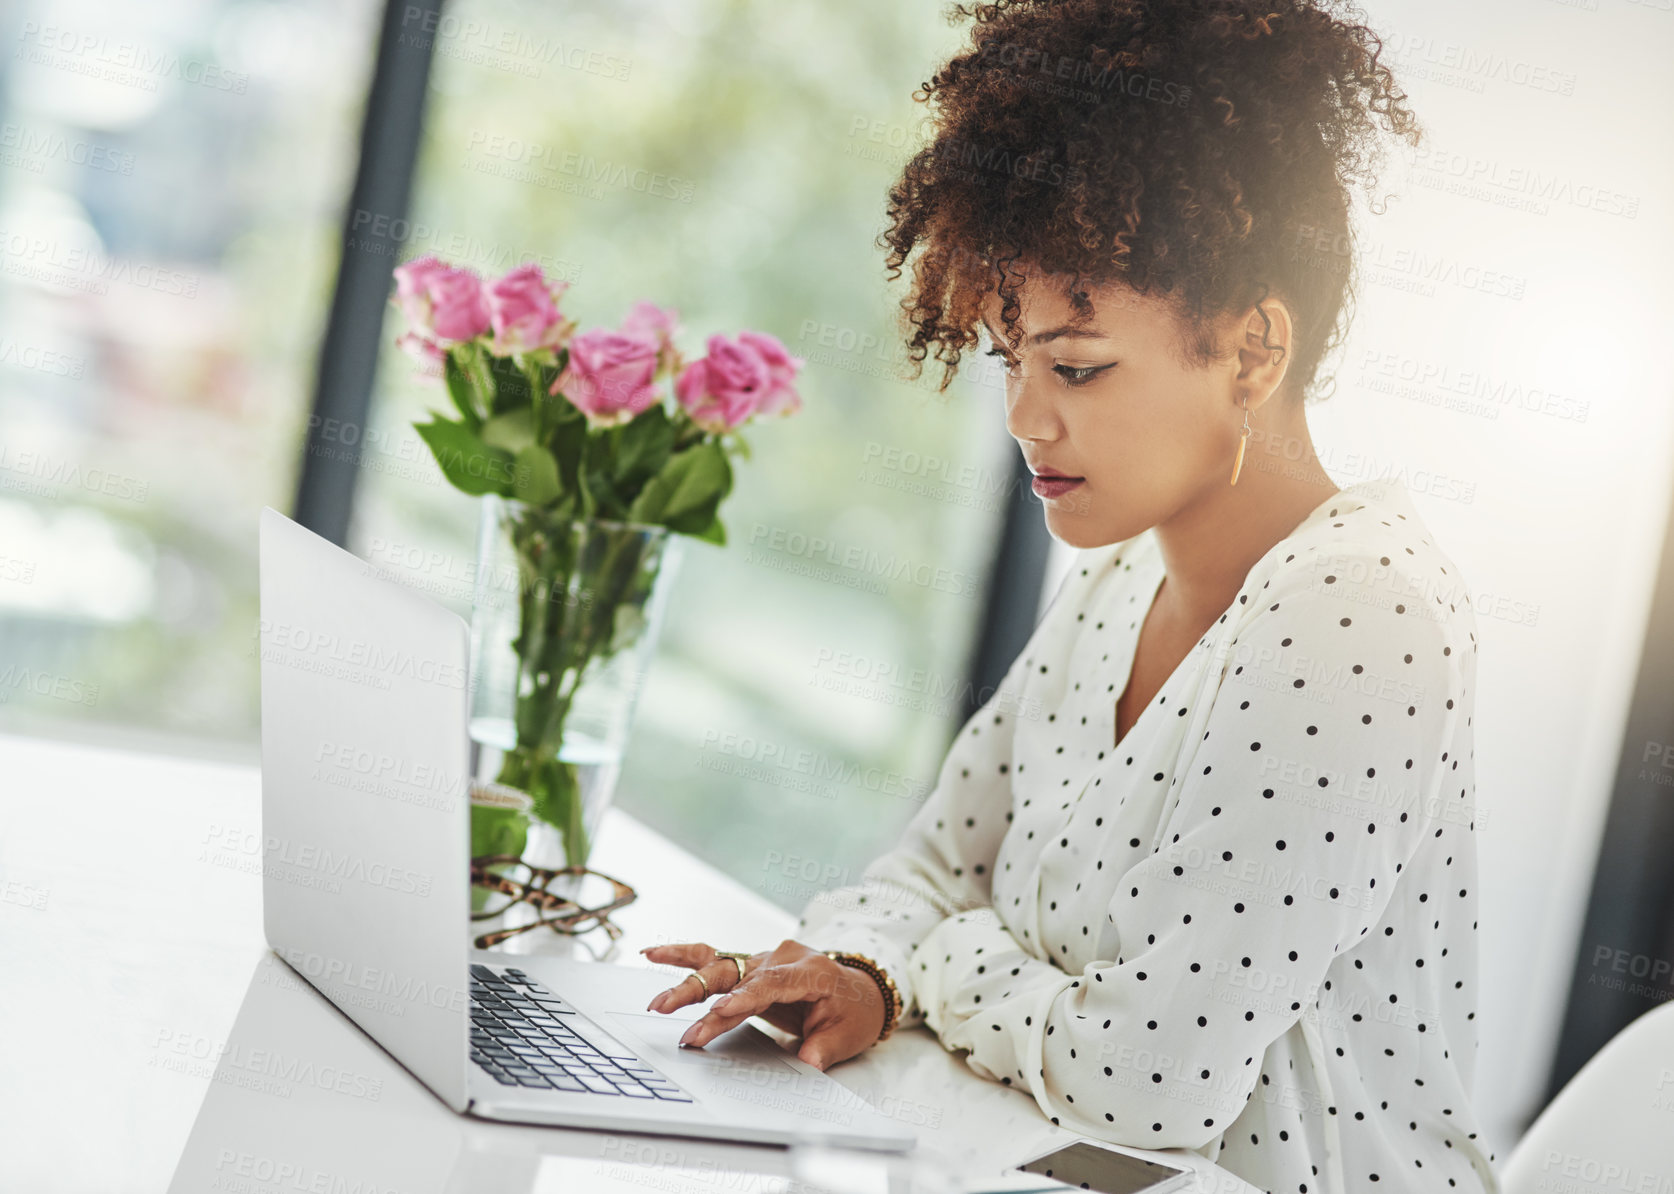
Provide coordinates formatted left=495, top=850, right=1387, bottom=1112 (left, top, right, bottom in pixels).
left=0, top=735, right=1254, bottom=1194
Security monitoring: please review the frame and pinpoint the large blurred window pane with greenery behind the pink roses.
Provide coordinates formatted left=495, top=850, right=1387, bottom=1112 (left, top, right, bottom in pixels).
left=350, top=0, right=1028, bottom=909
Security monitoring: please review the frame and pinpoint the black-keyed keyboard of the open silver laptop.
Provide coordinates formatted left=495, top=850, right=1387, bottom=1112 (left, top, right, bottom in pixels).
left=470, top=965, right=693, bottom=1104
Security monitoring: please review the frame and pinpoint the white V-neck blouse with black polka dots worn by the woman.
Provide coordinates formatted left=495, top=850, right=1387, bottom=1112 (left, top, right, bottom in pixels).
left=797, top=481, right=1498, bottom=1194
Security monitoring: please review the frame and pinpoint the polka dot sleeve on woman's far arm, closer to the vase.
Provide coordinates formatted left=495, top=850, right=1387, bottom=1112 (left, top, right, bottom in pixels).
left=797, top=552, right=1088, bottom=1028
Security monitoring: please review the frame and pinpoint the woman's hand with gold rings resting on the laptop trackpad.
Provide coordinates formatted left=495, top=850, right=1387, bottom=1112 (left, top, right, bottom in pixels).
left=639, top=938, right=886, bottom=1070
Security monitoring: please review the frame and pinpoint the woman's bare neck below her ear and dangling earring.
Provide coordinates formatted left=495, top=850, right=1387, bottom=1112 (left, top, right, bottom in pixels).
left=1157, top=402, right=1339, bottom=621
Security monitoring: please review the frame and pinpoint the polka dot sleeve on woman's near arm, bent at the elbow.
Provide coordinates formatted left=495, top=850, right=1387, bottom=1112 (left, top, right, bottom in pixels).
left=914, top=549, right=1468, bottom=1149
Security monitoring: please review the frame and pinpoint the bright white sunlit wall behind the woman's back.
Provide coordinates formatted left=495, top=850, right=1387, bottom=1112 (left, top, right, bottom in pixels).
left=1043, top=0, right=1674, bottom=1161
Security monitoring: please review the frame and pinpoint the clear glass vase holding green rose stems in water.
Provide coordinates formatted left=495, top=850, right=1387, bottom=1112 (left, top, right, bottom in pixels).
left=470, top=494, right=680, bottom=889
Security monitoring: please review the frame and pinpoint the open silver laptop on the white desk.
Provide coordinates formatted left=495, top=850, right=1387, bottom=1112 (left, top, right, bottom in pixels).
left=259, top=507, right=917, bottom=1152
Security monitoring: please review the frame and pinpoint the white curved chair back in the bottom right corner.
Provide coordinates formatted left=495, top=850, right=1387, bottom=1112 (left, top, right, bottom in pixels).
left=1500, top=1005, right=1674, bottom=1194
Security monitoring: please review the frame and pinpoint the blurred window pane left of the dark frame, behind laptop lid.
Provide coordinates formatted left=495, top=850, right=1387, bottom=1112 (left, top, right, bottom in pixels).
left=0, top=0, right=380, bottom=749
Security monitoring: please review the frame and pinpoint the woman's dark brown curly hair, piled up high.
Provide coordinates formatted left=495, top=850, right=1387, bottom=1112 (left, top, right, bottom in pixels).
left=879, top=0, right=1421, bottom=400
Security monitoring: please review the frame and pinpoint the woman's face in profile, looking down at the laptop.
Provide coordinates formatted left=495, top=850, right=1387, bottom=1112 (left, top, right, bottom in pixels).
left=983, top=278, right=1254, bottom=548
